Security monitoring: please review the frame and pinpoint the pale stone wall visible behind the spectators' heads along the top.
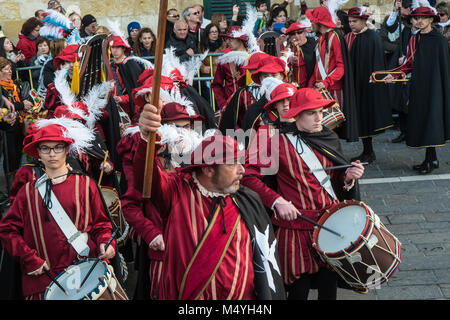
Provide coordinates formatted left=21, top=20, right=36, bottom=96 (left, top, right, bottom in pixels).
left=0, top=0, right=393, bottom=43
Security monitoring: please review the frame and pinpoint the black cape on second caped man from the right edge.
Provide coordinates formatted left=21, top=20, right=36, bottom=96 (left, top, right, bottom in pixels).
left=350, top=29, right=392, bottom=138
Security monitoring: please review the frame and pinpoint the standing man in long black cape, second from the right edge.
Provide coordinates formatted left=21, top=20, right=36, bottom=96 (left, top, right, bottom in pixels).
left=345, top=7, right=392, bottom=163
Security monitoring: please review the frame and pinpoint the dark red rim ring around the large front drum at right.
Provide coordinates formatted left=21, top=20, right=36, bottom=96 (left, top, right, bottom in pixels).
left=313, top=200, right=374, bottom=259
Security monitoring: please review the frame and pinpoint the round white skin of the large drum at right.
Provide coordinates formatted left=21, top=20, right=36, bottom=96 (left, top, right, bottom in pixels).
left=317, top=205, right=367, bottom=254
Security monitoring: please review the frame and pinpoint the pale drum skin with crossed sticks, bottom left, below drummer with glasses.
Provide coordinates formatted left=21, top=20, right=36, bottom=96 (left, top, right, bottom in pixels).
left=45, top=259, right=109, bottom=300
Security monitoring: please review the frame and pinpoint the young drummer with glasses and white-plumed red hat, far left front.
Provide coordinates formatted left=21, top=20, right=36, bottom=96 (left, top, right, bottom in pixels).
left=0, top=118, right=115, bottom=299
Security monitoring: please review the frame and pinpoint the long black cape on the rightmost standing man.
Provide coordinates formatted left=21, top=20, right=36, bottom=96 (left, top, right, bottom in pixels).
left=406, top=28, right=450, bottom=148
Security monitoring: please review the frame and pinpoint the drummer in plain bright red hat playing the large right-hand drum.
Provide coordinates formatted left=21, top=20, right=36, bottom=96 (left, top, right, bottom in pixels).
left=243, top=88, right=364, bottom=300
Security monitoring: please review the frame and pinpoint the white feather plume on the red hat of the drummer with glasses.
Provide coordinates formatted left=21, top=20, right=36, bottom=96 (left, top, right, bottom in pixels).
left=36, top=117, right=95, bottom=154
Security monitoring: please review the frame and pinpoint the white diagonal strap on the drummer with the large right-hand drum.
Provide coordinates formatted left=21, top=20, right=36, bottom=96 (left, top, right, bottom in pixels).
left=286, top=133, right=337, bottom=200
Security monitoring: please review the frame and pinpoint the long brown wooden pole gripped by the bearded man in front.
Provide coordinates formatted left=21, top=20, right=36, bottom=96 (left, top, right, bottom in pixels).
left=142, top=0, right=167, bottom=199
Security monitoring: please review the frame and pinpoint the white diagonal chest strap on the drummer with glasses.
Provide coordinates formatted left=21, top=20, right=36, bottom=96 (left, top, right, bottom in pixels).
left=35, top=173, right=89, bottom=257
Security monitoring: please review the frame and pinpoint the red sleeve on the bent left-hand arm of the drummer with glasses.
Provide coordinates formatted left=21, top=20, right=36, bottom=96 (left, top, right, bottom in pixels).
left=0, top=188, right=45, bottom=273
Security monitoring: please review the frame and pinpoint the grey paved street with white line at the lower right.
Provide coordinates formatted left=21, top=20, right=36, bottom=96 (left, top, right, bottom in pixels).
left=326, top=130, right=450, bottom=300
